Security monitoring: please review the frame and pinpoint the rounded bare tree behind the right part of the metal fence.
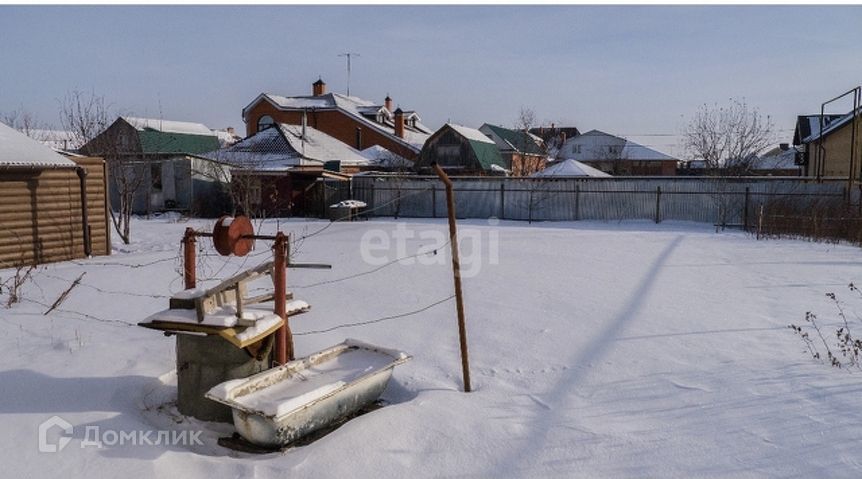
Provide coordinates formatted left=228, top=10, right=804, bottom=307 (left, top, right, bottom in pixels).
left=683, top=99, right=773, bottom=175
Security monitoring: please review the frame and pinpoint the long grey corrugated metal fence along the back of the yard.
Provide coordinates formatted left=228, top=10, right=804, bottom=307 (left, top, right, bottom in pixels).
left=352, top=175, right=859, bottom=226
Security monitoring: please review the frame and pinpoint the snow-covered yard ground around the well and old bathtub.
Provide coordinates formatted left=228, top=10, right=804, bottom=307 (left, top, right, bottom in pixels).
left=0, top=219, right=862, bottom=479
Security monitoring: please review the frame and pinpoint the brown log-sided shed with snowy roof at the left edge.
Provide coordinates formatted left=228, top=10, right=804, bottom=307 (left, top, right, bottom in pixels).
left=0, top=123, right=111, bottom=268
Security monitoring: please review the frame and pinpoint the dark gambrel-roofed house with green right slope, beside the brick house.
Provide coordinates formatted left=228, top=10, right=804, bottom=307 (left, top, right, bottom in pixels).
left=416, top=123, right=510, bottom=175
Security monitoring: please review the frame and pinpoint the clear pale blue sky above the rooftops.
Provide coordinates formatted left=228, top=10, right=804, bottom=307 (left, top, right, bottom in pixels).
left=0, top=6, right=862, bottom=153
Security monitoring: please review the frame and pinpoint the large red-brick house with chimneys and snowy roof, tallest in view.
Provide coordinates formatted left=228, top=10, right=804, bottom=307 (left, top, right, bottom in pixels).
left=242, top=80, right=432, bottom=160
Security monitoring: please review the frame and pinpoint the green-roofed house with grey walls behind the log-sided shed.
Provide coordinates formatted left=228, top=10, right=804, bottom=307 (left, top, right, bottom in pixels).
left=80, top=116, right=230, bottom=216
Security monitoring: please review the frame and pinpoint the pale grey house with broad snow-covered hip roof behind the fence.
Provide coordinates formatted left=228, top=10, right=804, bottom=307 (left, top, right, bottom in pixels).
left=556, top=130, right=679, bottom=176
